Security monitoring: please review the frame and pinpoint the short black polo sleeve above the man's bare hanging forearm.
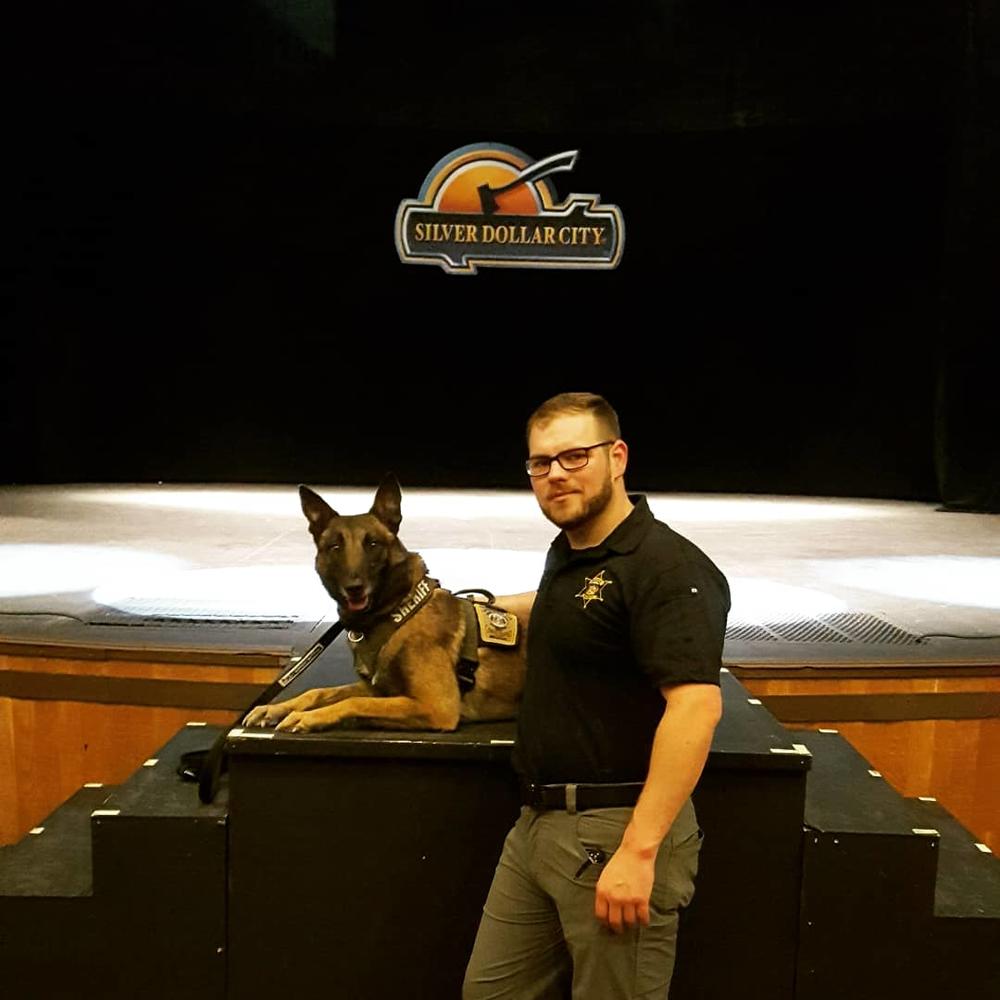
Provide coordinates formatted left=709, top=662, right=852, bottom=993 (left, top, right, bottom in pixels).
left=629, top=562, right=729, bottom=687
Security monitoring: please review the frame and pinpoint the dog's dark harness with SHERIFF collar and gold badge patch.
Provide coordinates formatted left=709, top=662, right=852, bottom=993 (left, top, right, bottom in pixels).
left=347, top=576, right=518, bottom=694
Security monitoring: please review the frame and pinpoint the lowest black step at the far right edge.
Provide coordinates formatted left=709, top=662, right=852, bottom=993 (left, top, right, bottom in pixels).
left=904, top=799, right=1000, bottom=997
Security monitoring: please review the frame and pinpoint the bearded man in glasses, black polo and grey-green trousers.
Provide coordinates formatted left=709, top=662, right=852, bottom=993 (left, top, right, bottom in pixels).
left=463, top=393, right=729, bottom=1000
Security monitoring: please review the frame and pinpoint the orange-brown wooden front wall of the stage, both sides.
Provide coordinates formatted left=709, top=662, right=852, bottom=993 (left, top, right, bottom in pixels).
left=0, top=655, right=1000, bottom=854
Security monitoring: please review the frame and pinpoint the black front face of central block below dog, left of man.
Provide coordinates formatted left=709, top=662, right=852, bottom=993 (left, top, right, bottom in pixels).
left=229, top=759, right=518, bottom=1000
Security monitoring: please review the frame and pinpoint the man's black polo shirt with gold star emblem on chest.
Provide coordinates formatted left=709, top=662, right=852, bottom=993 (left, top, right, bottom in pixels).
left=514, top=495, right=729, bottom=784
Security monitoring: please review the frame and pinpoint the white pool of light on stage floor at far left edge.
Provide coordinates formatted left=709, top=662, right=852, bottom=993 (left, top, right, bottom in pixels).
left=0, top=545, right=188, bottom=597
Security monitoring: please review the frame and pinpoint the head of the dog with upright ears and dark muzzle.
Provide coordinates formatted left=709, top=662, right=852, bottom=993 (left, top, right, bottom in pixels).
left=299, top=473, right=408, bottom=618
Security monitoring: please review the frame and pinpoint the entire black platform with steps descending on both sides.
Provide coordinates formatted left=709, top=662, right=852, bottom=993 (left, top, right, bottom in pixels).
left=0, top=671, right=1000, bottom=1000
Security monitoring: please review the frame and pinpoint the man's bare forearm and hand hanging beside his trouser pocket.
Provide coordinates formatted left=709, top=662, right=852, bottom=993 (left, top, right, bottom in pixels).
left=594, top=684, right=722, bottom=933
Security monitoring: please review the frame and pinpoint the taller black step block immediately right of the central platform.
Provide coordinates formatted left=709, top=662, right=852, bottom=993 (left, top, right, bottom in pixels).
left=789, top=730, right=940, bottom=1000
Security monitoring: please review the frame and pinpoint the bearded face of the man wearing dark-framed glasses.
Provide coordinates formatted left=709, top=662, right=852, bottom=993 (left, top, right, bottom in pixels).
left=528, top=413, right=612, bottom=529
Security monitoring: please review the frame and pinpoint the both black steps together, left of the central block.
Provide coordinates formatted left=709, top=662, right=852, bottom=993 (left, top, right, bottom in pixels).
left=0, top=725, right=227, bottom=1000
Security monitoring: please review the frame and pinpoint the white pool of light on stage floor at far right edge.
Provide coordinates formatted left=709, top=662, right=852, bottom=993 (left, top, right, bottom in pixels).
left=811, top=555, right=1000, bottom=609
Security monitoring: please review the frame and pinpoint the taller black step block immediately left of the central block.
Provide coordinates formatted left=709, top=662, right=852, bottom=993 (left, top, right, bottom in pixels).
left=92, top=724, right=227, bottom=1000
